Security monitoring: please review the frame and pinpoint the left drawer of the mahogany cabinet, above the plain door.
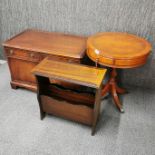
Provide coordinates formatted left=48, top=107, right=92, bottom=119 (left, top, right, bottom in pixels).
left=5, top=49, right=40, bottom=62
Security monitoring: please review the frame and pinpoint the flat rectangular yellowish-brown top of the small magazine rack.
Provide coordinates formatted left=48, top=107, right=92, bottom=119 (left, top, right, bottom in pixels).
left=32, top=58, right=106, bottom=88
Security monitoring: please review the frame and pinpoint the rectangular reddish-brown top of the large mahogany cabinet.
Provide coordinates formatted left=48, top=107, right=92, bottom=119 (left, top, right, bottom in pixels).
left=3, top=30, right=87, bottom=58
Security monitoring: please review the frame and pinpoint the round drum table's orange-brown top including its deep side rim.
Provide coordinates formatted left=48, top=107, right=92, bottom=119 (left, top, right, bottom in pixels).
left=87, top=32, right=151, bottom=68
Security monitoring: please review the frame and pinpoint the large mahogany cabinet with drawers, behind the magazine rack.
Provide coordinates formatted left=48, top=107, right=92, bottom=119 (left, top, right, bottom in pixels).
left=3, top=29, right=87, bottom=91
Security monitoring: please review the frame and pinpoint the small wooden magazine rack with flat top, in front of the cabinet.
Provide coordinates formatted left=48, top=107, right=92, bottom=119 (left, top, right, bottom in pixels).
left=32, top=58, right=106, bottom=135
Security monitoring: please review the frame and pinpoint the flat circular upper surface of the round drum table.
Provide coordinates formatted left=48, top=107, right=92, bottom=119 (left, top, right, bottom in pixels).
left=87, top=32, right=151, bottom=59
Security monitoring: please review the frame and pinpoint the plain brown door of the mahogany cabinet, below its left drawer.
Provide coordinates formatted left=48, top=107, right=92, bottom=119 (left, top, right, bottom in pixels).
left=8, top=58, right=37, bottom=83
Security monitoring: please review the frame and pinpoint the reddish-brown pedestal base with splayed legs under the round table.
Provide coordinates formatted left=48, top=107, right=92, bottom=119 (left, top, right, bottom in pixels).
left=102, top=68, right=126, bottom=113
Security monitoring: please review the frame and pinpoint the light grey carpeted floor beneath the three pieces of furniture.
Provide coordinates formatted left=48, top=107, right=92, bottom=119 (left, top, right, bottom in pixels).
left=0, top=64, right=155, bottom=155
